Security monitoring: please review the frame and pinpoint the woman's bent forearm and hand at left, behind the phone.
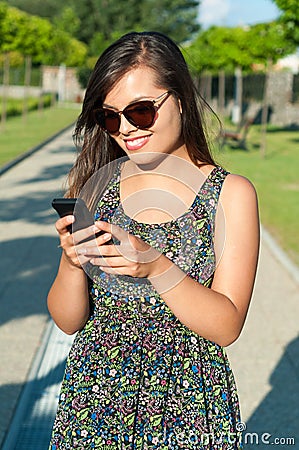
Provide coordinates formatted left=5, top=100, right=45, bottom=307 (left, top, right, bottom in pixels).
left=48, top=216, right=111, bottom=334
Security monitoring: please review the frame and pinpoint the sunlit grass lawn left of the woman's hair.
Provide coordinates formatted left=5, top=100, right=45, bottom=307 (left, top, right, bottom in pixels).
left=0, top=105, right=80, bottom=166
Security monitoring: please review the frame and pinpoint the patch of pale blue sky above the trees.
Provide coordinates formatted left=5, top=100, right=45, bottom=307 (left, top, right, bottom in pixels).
left=199, top=0, right=280, bottom=28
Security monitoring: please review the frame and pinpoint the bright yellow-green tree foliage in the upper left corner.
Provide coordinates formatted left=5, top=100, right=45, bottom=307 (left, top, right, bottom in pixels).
left=0, top=3, right=87, bottom=66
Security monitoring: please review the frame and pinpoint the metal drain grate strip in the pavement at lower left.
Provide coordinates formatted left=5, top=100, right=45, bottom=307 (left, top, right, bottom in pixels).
left=2, top=321, right=74, bottom=450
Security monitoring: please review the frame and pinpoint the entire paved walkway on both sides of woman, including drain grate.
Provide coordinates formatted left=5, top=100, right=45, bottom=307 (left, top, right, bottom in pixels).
left=0, top=130, right=299, bottom=450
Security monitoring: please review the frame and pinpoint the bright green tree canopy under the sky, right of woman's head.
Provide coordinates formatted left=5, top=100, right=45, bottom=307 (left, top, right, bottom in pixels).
left=184, top=22, right=294, bottom=73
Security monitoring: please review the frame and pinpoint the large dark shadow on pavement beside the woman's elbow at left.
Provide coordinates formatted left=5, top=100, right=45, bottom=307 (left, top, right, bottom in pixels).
left=0, top=236, right=61, bottom=325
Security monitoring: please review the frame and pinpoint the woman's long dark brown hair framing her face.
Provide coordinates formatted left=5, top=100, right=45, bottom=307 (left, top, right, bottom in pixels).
left=68, top=32, right=215, bottom=205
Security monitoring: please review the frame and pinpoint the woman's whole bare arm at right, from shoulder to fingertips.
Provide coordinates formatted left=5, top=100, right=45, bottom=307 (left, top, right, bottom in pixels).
left=79, top=174, right=259, bottom=346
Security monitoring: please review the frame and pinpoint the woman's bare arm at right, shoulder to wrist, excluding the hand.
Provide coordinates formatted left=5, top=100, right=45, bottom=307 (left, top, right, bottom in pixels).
left=150, top=175, right=259, bottom=346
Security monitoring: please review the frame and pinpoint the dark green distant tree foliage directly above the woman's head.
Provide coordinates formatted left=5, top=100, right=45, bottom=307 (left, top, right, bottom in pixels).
left=8, top=0, right=199, bottom=46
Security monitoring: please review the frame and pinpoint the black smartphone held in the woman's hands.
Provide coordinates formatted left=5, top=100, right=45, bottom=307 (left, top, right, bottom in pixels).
left=52, top=198, right=94, bottom=233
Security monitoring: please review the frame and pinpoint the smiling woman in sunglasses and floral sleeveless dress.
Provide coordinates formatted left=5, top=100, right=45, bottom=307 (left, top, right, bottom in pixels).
left=48, top=32, right=259, bottom=450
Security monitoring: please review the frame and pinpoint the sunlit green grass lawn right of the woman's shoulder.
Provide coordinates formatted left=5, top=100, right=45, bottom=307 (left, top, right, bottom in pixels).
left=218, top=125, right=299, bottom=264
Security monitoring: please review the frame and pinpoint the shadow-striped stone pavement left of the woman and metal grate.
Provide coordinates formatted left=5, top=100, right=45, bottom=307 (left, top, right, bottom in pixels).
left=0, top=125, right=75, bottom=450
